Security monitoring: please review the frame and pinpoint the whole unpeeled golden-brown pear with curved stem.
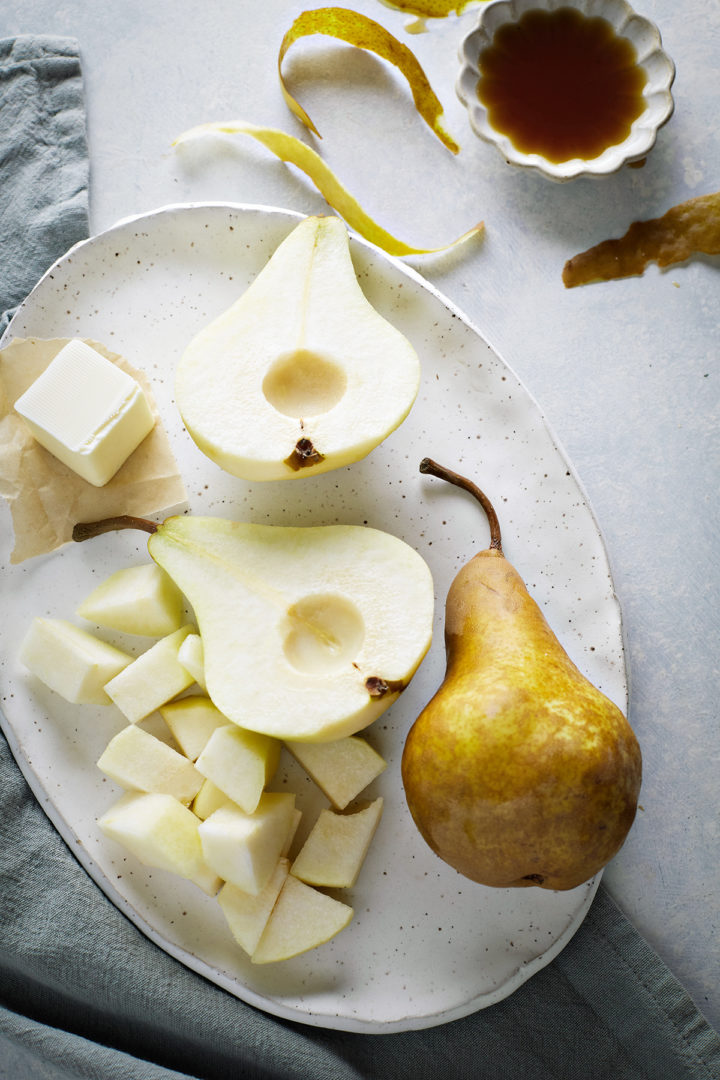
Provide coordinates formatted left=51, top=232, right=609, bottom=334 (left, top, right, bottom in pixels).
left=402, top=458, right=641, bottom=890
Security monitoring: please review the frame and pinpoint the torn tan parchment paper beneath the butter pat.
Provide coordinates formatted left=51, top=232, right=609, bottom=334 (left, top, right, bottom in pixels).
left=0, top=338, right=187, bottom=564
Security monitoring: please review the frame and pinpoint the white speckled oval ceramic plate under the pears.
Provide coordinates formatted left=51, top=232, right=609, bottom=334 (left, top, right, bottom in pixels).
left=0, top=204, right=626, bottom=1032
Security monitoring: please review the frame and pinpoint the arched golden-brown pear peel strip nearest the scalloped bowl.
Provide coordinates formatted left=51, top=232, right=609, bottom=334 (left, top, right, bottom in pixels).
left=277, top=8, right=460, bottom=153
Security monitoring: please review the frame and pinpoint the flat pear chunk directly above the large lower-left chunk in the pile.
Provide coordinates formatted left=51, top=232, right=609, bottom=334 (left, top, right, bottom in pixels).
left=97, top=724, right=203, bottom=804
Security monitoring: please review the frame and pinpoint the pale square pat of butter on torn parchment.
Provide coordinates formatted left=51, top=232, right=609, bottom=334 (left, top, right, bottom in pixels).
left=15, top=339, right=155, bottom=487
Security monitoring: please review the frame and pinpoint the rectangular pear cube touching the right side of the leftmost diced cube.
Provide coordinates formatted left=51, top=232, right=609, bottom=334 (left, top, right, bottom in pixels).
left=105, top=626, right=192, bottom=724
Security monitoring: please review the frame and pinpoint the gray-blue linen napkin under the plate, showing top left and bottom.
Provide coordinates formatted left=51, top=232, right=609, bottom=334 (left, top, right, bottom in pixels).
left=0, top=31, right=720, bottom=1080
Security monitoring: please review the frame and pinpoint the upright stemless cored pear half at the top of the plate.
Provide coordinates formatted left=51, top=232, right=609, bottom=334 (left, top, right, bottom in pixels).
left=175, top=211, right=420, bottom=481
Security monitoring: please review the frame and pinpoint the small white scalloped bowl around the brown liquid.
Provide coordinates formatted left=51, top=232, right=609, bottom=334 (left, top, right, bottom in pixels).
left=456, top=0, right=675, bottom=181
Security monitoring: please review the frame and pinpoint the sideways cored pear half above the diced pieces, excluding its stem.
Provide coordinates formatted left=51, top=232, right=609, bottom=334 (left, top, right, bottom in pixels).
left=143, top=516, right=434, bottom=741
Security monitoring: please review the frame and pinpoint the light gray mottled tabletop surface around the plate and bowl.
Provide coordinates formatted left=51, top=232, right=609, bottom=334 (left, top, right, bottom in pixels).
left=0, top=0, right=720, bottom=1027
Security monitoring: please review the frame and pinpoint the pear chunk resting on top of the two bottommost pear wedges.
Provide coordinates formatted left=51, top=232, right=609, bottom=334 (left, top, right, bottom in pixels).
left=195, top=792, right=295, bottom=896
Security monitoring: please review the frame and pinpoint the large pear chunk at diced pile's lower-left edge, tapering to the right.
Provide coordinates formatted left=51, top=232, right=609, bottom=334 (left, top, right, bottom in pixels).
left=98, top=792, right=222, bottom=896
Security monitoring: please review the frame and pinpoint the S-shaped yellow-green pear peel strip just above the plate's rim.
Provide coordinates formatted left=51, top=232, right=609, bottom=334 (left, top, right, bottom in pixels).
left=173, top=120, right=485, bottom=255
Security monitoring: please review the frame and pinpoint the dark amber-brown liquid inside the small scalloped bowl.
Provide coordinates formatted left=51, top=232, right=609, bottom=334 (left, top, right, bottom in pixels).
left=477, top=8, right=647, bottom=162
